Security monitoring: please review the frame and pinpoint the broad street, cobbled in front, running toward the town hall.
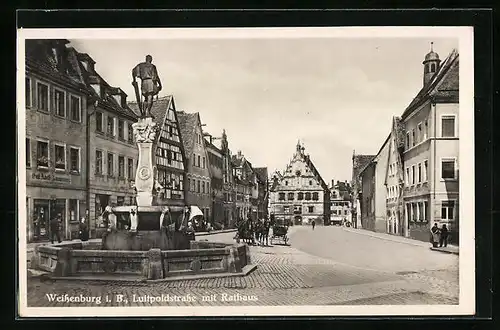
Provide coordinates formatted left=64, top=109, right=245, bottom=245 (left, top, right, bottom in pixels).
left=28, top=227, right=458, bottom=307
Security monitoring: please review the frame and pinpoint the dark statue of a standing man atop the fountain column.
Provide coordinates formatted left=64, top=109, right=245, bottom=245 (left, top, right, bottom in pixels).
left=132, top=55, right=162, bottom=117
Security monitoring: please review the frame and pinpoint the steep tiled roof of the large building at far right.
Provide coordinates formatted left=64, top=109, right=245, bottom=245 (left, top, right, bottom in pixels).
left=401, top=49, right=459, bottom=119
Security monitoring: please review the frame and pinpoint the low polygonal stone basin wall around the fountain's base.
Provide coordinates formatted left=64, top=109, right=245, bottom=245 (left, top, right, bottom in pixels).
left=30, top=241, right=256, bottom=281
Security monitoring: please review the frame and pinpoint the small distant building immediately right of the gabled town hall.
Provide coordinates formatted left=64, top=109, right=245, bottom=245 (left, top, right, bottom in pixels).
left=330, top=180, right=352, bottom=225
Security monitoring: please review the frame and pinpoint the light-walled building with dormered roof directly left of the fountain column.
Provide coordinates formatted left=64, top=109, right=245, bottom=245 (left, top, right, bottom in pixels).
left=77, top=53, right=139, bottom=237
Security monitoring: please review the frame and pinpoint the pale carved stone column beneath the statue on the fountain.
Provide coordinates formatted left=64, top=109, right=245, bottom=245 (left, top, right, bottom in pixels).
left=132, top=117, right=157, bottom=206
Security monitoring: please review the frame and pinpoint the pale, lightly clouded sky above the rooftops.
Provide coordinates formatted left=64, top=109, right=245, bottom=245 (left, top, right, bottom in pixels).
left=70, top=38, right=458, bottom=186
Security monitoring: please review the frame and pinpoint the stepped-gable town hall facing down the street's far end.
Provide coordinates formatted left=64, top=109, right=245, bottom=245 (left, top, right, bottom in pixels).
left=271, top=143, right=330, bottom=225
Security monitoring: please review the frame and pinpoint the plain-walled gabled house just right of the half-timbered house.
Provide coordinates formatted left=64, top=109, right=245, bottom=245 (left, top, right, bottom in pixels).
left=177, top=111, right=212, bottom=221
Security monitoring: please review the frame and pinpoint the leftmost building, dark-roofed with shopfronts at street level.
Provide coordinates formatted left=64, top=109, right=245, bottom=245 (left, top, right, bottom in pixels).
left=24, top=39, right=89, bottom=242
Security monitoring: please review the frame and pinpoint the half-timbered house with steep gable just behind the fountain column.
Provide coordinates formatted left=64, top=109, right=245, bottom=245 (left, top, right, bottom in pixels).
left=129, top=95, right=187, bottom=212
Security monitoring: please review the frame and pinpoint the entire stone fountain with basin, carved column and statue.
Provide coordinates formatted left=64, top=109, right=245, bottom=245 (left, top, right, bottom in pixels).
left=30, top=55, right=256, bottom=281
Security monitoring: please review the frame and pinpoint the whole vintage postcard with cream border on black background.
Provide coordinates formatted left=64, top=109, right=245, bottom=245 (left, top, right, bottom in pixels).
left=17, top=27, right=475, bottom=317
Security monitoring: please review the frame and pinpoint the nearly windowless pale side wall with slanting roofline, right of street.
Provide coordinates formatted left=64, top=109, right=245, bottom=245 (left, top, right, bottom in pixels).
left=359, top=135, right=391, bottom=233
